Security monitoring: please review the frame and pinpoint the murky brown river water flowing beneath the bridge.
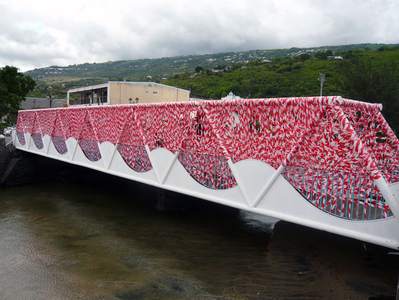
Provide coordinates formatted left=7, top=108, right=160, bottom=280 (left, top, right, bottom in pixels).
left=0, top=168, right=397, bottom=300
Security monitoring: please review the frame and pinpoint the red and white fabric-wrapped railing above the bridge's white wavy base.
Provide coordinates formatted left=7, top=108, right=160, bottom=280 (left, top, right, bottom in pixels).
left=17, top=97, right=399, bottom=220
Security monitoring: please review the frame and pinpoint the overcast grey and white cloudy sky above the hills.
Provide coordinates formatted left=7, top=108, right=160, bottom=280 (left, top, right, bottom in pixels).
left=0, top=0, right=399, bottom=70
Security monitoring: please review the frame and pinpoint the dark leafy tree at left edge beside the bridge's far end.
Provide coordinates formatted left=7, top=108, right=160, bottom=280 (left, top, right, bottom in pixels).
left=0, top=66, right=36, bottom=127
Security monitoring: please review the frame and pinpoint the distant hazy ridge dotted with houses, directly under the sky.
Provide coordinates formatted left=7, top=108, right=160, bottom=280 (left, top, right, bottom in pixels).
left=26, top=44, right=396, bottom=87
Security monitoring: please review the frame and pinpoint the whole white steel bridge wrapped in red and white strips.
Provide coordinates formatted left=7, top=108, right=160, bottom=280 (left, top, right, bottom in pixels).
left=13, top=97, right=399, bottom=249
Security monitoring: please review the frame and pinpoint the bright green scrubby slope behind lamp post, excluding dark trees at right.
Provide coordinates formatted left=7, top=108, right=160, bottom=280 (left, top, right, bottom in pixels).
left=166, top=56, right=341, bottom=99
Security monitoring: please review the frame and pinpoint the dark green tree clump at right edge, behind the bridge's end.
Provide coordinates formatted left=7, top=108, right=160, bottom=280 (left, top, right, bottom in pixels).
left=340, top=57, right=399, bottom=133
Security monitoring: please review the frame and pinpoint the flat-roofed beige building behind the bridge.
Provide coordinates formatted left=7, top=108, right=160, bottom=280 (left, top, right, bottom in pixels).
left=67, top=81, right=190, bottom=105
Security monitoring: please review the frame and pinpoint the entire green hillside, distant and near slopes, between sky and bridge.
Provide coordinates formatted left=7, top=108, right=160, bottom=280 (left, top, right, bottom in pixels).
left=22, top=44, right=399, bottom=132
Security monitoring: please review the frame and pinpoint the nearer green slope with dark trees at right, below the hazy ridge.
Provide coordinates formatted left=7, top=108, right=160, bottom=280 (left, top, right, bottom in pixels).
left=163, top=47, right=399, bottom=132
